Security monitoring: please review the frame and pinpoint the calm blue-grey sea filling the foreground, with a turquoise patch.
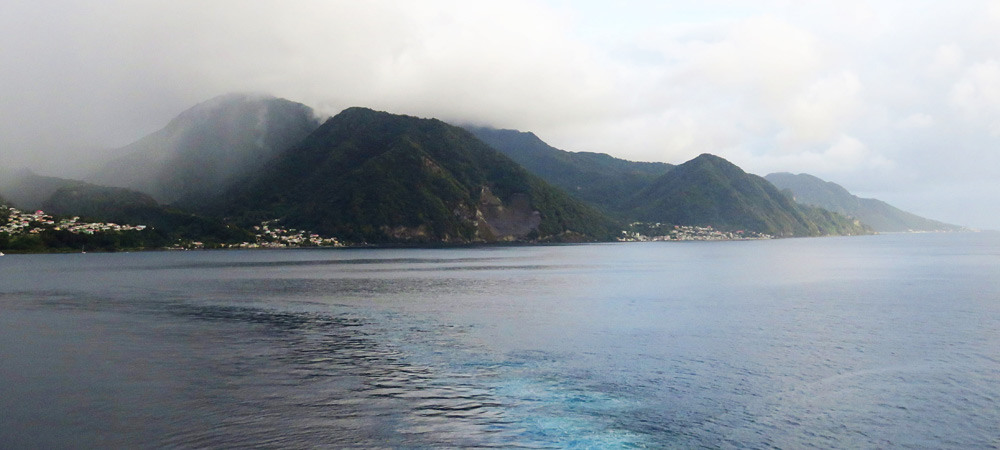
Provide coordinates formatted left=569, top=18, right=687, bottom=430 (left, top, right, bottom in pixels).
left=0, top=234, right=1000, bottom=449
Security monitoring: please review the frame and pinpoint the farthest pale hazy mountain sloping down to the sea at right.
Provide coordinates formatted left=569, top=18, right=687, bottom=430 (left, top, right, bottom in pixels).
left=765, top=172, right=962, bottom=232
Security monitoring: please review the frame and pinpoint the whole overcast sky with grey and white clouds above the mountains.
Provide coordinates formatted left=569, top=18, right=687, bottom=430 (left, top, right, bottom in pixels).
left=0, top=0, right=1000, bottom=229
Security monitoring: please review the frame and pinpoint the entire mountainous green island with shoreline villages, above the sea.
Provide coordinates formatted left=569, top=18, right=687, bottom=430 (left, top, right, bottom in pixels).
left=0, top=94, right=961, bottom=252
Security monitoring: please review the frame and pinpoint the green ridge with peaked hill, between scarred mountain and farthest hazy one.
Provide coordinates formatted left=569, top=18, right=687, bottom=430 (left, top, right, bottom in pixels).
left=466, top=127, right=871, bottom=236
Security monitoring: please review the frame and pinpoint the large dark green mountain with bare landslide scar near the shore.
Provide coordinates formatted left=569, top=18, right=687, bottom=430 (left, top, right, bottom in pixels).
left=189, top=108, right=617, bottom=243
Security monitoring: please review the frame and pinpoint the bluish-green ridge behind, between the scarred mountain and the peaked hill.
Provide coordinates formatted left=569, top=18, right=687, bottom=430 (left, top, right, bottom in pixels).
left=465, top=126, right=673, bottom=216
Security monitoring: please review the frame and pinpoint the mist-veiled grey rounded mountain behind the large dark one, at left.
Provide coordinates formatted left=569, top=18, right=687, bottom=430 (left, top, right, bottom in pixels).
left=88, top=94, right=319, bottom=203
